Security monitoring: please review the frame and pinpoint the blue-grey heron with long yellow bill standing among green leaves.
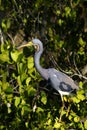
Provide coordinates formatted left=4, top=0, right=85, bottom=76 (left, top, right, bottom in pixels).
left=20, top=39, right=79, bottom=121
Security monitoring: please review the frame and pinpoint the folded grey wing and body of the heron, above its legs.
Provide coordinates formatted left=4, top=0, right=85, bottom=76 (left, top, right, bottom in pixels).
left=49, top=69, right=78, bottom=94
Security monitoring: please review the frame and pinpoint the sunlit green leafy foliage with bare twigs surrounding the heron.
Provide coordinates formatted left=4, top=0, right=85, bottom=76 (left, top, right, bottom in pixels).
left=0, top=0, right=87, bottom=130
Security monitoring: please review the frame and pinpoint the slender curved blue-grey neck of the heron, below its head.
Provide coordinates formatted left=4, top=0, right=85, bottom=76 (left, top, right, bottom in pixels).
left=34, top=51, right=48, bottom=80
